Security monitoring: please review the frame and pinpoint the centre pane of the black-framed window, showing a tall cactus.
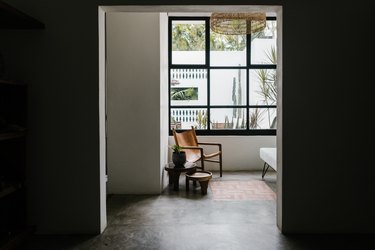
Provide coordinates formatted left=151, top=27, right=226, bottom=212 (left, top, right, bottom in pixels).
left=210, top=69, right=246, bottom=105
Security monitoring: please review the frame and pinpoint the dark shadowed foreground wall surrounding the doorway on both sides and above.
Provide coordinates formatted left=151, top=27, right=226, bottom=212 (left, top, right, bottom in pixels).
left=0, top=0, right=375, bottom=233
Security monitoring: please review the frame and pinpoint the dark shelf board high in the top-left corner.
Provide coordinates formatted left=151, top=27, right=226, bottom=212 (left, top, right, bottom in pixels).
left=0, top=1, right=44, bottom=29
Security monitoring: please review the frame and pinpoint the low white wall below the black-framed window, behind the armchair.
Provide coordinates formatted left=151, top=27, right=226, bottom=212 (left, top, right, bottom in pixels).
left=169, top=136, right=276, bottom=171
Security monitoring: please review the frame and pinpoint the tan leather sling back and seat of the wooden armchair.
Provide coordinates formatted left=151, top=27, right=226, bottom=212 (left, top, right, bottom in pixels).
left=173, top=127, right=201, bottom=162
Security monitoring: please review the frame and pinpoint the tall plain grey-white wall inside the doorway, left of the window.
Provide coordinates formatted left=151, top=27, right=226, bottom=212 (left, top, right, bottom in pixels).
left=106, top=12, right=162, bottom=194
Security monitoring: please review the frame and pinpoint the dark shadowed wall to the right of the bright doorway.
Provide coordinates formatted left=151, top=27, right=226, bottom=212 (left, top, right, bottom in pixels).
left=283, top=1, right=375, bottom=233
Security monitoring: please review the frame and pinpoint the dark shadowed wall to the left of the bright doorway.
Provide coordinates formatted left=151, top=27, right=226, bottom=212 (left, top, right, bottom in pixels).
left=0, top=1, right=100, bottom=233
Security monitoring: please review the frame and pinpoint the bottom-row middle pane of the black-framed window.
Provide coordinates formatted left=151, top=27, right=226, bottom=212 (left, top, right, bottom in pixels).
left=210, top=108, right=246, bottom=130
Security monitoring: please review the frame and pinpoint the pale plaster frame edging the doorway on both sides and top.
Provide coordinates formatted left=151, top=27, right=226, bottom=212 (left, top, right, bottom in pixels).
left=98, top=5, right=283, bottom=232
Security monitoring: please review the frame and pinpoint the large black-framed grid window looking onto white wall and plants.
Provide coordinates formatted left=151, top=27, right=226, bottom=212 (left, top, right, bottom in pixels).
left=168, top=17, right=277, bottom=135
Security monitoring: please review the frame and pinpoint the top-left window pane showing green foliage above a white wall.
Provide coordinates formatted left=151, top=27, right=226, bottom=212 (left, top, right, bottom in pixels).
left=172, top=20, right=206, bottom=64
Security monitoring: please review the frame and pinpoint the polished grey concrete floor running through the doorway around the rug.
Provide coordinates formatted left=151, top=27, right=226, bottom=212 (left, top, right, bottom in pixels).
left=21, top=171, right=375, bottom=250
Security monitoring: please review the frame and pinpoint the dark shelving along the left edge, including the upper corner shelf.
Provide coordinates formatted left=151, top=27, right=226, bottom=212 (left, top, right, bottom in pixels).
left=0, top=1, right=44, bottom=249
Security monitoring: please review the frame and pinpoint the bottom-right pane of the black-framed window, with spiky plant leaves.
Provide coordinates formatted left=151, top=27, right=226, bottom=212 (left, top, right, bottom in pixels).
left=249, top=108, right=276, bottom=129
